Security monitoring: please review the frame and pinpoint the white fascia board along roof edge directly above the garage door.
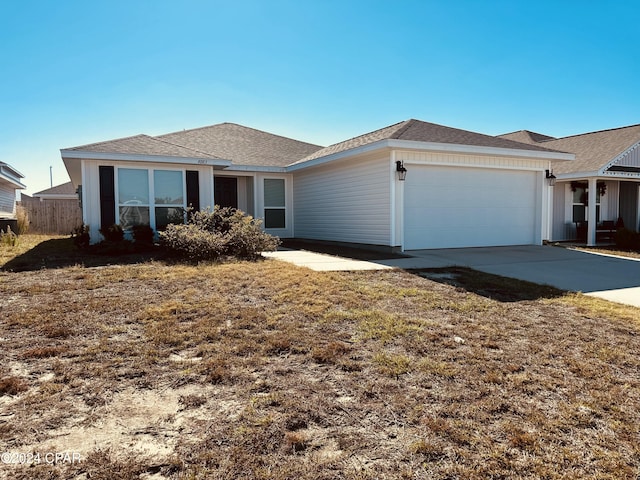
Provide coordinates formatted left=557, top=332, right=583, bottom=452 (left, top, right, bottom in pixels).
left=386, top=140, right=576, bottom=161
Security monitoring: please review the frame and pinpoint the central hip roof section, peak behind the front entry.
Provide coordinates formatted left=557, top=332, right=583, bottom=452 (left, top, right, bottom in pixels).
left=155, top=123, right=322, bottom=167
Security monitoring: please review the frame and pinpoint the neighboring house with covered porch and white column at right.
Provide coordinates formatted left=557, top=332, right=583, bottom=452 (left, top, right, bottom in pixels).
left=500, top=125, right=640, bottom=245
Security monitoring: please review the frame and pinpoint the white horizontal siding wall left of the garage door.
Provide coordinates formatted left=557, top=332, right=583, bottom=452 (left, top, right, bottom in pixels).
left=293, top=154, right=391, bottom=246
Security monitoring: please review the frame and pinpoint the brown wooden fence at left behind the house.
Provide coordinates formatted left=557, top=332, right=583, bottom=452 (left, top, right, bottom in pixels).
left=18, top=198, right=82, bottom=235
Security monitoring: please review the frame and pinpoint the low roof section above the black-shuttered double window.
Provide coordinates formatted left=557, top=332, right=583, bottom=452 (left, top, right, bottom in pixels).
left=65, top=135, right=222, bottom=158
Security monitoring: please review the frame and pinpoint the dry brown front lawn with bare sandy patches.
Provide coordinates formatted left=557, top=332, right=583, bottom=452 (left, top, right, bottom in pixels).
left=0, top=235, right=640, bottom=480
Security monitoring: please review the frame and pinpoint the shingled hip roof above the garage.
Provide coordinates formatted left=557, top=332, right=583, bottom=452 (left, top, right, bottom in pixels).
left=296, top=119, right=554, bottom=163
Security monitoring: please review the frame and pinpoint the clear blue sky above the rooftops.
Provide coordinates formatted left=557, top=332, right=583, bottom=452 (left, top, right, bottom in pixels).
left=0, top=0, right=640, bottom=193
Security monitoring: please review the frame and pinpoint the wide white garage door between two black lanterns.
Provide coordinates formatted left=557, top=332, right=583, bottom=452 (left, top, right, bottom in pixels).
left=404, top=166, right=537, bottom=250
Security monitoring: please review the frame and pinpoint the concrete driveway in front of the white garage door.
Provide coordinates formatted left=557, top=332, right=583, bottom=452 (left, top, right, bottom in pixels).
left=376, top=245, right=640, bottom=307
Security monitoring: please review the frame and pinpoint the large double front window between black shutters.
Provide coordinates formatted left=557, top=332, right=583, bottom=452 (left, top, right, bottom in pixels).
left=118, top=168, right=185, bottom=231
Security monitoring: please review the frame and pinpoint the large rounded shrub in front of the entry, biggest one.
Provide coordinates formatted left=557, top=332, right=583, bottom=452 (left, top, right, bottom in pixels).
left=159, top=206, right=280, bottom=261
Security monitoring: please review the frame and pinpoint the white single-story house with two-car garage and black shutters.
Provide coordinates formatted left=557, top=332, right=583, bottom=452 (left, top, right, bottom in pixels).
left=61, top=120, right=574, bottom=250
